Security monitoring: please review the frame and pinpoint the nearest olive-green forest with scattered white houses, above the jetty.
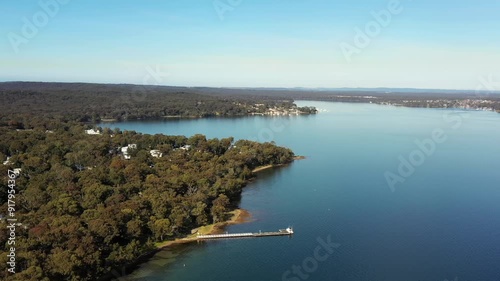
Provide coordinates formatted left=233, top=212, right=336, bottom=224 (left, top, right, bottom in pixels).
left=0, top=122, right=294, bottom=281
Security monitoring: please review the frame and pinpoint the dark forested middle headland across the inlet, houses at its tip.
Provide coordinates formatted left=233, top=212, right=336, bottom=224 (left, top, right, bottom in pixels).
left=0, top=82, right=316, bottom=123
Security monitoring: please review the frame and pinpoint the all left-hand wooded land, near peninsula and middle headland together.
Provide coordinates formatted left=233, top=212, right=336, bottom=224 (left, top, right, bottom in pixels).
left=0, top=83, right=315, bottom=281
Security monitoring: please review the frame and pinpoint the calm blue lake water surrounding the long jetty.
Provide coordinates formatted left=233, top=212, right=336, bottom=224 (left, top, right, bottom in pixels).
left=101, top=102, right=500, bottom=281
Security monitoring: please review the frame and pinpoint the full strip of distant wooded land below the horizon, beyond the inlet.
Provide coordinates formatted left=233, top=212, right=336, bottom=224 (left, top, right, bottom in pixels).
left=0, top=82, right=500, bottom=118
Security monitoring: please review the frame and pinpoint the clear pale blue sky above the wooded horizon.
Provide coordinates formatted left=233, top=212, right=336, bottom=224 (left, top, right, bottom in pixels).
left=0, top=0, right=500, bottom=90
